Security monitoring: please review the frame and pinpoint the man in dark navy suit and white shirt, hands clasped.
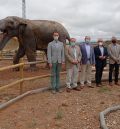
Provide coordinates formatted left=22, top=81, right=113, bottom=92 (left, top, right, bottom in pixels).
left=94, top=39, right=108, bottom=87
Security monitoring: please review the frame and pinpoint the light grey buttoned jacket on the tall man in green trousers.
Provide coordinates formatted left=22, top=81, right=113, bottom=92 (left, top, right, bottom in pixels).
left=47, top=40, right=65, bottom=63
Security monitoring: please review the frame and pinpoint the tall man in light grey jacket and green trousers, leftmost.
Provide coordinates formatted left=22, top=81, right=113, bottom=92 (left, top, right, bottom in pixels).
left=47, top=32, right=65, bottom=94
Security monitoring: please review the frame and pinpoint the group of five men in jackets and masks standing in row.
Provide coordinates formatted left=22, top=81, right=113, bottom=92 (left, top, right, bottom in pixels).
left=47, top=32, right=120, bottom=94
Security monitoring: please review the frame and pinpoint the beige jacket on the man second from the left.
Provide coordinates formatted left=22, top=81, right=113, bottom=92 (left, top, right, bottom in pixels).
left=65, top=45, right=82, bottom=69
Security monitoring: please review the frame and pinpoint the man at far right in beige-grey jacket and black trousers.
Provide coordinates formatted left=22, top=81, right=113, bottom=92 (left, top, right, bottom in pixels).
left=108, top=37, right=120, bottom=86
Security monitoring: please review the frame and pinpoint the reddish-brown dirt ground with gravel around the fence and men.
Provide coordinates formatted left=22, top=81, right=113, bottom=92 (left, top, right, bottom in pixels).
left=0, top=62, right=120, bottom=129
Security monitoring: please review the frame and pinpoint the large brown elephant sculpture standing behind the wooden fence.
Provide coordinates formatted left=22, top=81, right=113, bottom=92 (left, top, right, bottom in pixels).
left=0, top=16, right=70, bottom=69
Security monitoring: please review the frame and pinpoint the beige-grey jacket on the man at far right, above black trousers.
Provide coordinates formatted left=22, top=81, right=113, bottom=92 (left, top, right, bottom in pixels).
left=108, top=43, right=120, bottom=64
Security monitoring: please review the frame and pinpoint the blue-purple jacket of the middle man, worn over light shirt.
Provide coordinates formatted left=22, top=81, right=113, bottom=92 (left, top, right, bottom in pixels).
left=80, top=43, right=95, bottom=64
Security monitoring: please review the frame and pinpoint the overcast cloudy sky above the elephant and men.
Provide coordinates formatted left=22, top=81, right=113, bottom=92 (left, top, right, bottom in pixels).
left=0, top=0, right=120, bottom=39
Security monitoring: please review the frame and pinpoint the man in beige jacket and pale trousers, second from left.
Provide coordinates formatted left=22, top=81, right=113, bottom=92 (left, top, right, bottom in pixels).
left=65, top=38, right=82, bottom=92
